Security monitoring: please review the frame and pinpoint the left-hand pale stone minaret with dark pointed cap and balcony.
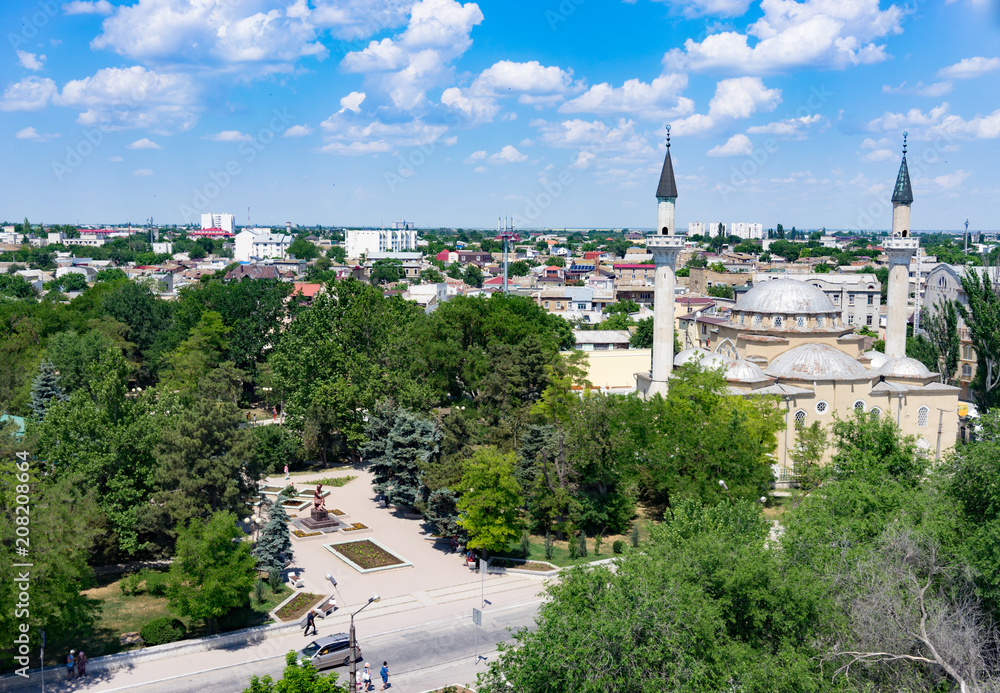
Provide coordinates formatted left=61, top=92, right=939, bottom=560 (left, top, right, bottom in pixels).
left=646, top=125, right=684, bottom=397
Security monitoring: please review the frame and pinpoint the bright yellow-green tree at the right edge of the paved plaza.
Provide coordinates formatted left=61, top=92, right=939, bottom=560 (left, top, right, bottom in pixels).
left=457, top=448, right=523, bottom=552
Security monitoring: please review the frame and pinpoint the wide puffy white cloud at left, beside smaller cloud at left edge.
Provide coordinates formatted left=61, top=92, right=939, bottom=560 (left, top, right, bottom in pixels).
left=52, top=65, right=197, bottom=131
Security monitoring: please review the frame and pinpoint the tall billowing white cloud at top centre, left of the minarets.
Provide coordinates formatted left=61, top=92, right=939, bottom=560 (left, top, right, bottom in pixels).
left=341, top=0, right=483, bottom=111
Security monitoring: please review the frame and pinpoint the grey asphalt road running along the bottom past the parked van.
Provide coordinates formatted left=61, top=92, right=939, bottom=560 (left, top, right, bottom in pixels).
left=91, top=600, right=540, bottom=693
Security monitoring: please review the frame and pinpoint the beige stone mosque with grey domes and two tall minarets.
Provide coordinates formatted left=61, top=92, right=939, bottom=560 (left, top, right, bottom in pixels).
left=635, top=128, right=960, bottom=483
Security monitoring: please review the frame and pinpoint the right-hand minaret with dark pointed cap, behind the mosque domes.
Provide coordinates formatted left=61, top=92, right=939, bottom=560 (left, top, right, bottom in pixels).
left=882, top=132, right=920, bottom=359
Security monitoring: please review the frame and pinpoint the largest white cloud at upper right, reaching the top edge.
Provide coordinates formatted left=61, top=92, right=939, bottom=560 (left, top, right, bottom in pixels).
left=664, top=0, right=904, bottom=74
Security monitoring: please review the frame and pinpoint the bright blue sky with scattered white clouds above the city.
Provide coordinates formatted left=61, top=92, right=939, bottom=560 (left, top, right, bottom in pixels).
left=0, top=0, right=1000, bottom=229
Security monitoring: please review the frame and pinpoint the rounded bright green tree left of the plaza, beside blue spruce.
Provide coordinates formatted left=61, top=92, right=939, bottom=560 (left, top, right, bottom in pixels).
left=167, top=512, right=257, bottom=632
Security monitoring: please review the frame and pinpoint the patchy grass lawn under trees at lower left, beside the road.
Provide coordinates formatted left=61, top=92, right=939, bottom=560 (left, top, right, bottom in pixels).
left=76, top=580, right=292, bottom=657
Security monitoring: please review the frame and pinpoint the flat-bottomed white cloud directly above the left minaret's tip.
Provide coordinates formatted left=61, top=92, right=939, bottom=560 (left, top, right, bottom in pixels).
left=559, top=74, right=694, bottom=120
